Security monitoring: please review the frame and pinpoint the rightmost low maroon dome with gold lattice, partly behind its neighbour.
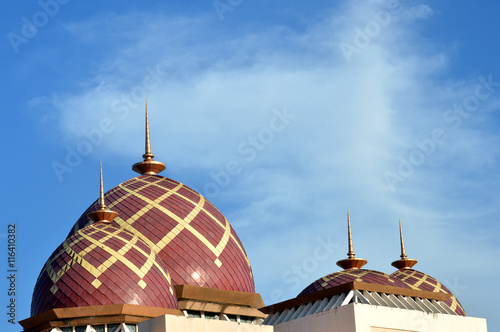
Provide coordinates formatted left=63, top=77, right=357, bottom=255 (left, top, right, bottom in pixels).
left=391, top=269, right=465, bottom=316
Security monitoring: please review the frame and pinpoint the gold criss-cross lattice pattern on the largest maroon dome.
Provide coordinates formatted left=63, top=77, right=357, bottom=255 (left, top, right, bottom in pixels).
left=108, top=177, right=251, bottom=273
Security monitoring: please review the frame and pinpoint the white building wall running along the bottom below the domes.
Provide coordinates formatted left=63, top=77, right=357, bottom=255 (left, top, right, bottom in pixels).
left=138, top=303, right=487, bottom=332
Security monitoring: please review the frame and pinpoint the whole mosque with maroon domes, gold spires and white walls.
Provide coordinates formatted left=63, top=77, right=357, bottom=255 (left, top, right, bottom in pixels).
left=20, top=104, right=487, bottom=332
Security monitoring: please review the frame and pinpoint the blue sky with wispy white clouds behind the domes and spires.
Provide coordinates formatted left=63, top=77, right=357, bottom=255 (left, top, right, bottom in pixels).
left=0, top=0, right=500, bottom=331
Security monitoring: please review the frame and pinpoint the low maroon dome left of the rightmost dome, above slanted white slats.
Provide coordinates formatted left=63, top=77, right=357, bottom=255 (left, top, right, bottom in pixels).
left=298, top=269, right=410, bottom=296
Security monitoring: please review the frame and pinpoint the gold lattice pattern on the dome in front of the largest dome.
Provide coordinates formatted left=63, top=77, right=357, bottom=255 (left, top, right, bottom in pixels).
left=42, top=225, right=174, bottom=295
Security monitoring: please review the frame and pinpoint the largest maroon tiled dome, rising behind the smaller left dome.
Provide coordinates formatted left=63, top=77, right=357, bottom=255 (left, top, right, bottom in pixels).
left=66, top=175, right=255, bottom=293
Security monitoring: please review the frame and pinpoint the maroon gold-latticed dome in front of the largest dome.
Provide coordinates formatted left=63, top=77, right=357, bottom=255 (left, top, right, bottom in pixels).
left=31, top=222, right=177, bottom=316
